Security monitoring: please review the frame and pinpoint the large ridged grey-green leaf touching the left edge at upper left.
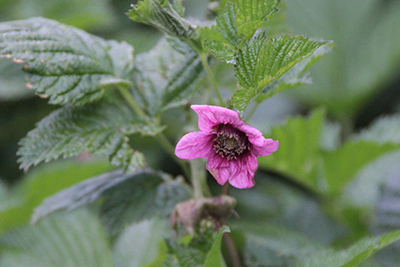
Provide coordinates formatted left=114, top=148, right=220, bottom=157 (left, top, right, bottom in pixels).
left=0, top=18, right=133, bottom=105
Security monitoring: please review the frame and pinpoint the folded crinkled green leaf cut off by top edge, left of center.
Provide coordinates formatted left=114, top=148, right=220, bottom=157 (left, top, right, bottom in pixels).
left=128, top=0, right=196, bottom=39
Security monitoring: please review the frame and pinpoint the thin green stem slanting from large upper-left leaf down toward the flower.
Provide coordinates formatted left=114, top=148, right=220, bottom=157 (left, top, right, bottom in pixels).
left=118, top=86, right=190, bottom=177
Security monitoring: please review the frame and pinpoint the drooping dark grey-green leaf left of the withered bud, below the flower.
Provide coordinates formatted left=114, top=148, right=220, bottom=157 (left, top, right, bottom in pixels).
left=32, top=169, right=190, bottom=235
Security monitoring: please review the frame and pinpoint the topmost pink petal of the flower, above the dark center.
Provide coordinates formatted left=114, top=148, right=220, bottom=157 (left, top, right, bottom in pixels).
left=191, top=105, right=244, bottom=133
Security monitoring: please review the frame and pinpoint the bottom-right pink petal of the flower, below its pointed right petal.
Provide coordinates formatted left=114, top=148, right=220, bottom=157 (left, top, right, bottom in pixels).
left=229, top=153, right=258, bottom=189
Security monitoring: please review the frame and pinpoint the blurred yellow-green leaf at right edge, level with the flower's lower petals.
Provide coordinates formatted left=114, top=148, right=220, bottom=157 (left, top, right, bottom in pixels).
left=323, top=140, right=400, bottom=194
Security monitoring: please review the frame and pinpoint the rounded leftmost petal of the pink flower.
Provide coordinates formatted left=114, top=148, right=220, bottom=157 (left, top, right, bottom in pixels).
left=175, top=132, right=214, bottom=159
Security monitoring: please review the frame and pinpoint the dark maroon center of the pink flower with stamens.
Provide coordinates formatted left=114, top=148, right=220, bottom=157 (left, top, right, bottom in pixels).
left=214, top=124, right=250, bottom=161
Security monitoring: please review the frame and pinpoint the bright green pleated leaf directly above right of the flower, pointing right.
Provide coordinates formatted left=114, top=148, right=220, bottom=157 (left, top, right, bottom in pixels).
left=232, top=33, right=331, bottom=112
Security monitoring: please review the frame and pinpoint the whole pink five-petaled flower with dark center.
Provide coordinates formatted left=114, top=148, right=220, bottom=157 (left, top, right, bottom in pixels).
left=175, top=105, right=279, bottom=188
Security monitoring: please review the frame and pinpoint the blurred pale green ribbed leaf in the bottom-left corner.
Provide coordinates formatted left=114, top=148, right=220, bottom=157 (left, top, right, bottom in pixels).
left=0, top=210, right=114, bottom=267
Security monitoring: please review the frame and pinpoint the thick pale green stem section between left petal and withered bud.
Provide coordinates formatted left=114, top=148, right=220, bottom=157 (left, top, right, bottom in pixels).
left=190, top=159, right=211, bottom=198
